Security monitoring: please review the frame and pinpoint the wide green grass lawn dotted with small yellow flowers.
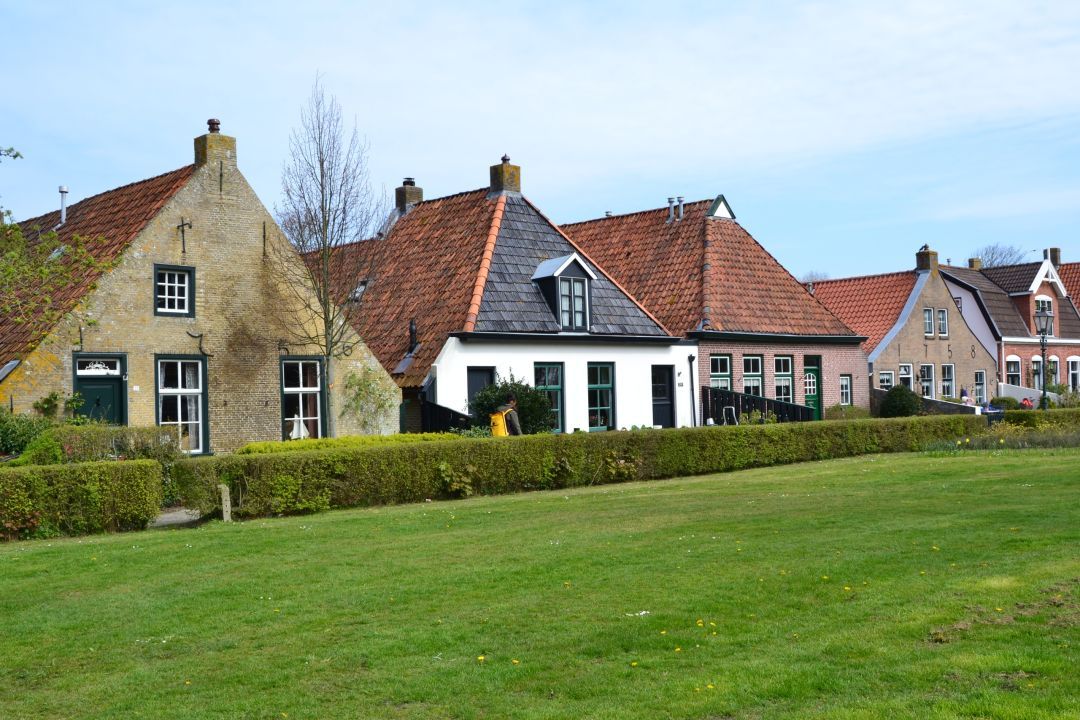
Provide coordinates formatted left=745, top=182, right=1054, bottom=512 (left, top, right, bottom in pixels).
left=0, top=450, right=1080, bottom=720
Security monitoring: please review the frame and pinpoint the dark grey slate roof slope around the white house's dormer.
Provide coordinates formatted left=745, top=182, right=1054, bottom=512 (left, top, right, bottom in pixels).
left=475, top=195, right=666, bottom=336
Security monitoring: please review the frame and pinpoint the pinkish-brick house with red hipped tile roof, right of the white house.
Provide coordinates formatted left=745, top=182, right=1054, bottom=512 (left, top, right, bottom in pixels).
left=563, top=195, right=869, bottom=418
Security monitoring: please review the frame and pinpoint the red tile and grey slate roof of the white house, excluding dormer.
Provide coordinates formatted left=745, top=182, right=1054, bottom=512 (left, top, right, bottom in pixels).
left=335, top=188, right=666, bottom=388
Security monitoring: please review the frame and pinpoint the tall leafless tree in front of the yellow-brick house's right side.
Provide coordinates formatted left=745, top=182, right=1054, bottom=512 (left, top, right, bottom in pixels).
left=274, top=78, right=387, bottom=437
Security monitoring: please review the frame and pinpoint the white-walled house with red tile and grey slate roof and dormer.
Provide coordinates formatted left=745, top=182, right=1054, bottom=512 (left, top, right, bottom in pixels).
left=336, top=157, right=696, bottom=432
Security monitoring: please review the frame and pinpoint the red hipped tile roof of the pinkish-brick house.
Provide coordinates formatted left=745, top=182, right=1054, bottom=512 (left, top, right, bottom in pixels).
left=563, top=201, right=854, bottom=336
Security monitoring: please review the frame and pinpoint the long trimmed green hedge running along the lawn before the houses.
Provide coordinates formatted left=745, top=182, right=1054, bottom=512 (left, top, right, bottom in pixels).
left=174, top=415, right=986, bottom=517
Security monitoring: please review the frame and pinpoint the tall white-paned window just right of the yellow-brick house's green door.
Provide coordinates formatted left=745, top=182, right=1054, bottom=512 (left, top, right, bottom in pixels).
left=157, top=357, right=206, bottom=453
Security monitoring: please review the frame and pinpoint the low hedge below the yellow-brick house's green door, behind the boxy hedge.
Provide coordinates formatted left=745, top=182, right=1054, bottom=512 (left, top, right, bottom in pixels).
left=15, top=424, right=180, bottom=466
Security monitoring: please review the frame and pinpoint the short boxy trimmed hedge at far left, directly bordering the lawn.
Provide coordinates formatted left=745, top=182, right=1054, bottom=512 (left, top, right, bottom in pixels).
left=0, top=460, right=162, bottom=540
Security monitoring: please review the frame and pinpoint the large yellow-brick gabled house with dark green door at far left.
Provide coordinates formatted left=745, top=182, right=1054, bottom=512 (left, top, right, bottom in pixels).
left=0, top=120, right=396, bottom=454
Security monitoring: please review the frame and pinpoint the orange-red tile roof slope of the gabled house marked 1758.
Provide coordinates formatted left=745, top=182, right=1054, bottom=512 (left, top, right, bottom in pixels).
left=813, top=270, right=916, bottom=353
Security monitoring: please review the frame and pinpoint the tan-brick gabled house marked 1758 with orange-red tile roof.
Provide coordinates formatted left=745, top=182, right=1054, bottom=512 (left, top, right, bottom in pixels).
left=813, top=245, right=997, bottom=404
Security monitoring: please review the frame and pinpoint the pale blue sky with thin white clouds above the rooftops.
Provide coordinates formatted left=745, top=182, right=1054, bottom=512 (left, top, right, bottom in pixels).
left=0, top=0, right=1080, bottom=277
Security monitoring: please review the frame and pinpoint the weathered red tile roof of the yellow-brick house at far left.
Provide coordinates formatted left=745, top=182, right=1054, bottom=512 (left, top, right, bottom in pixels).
left=0, top=165, right=194, bottom=362
